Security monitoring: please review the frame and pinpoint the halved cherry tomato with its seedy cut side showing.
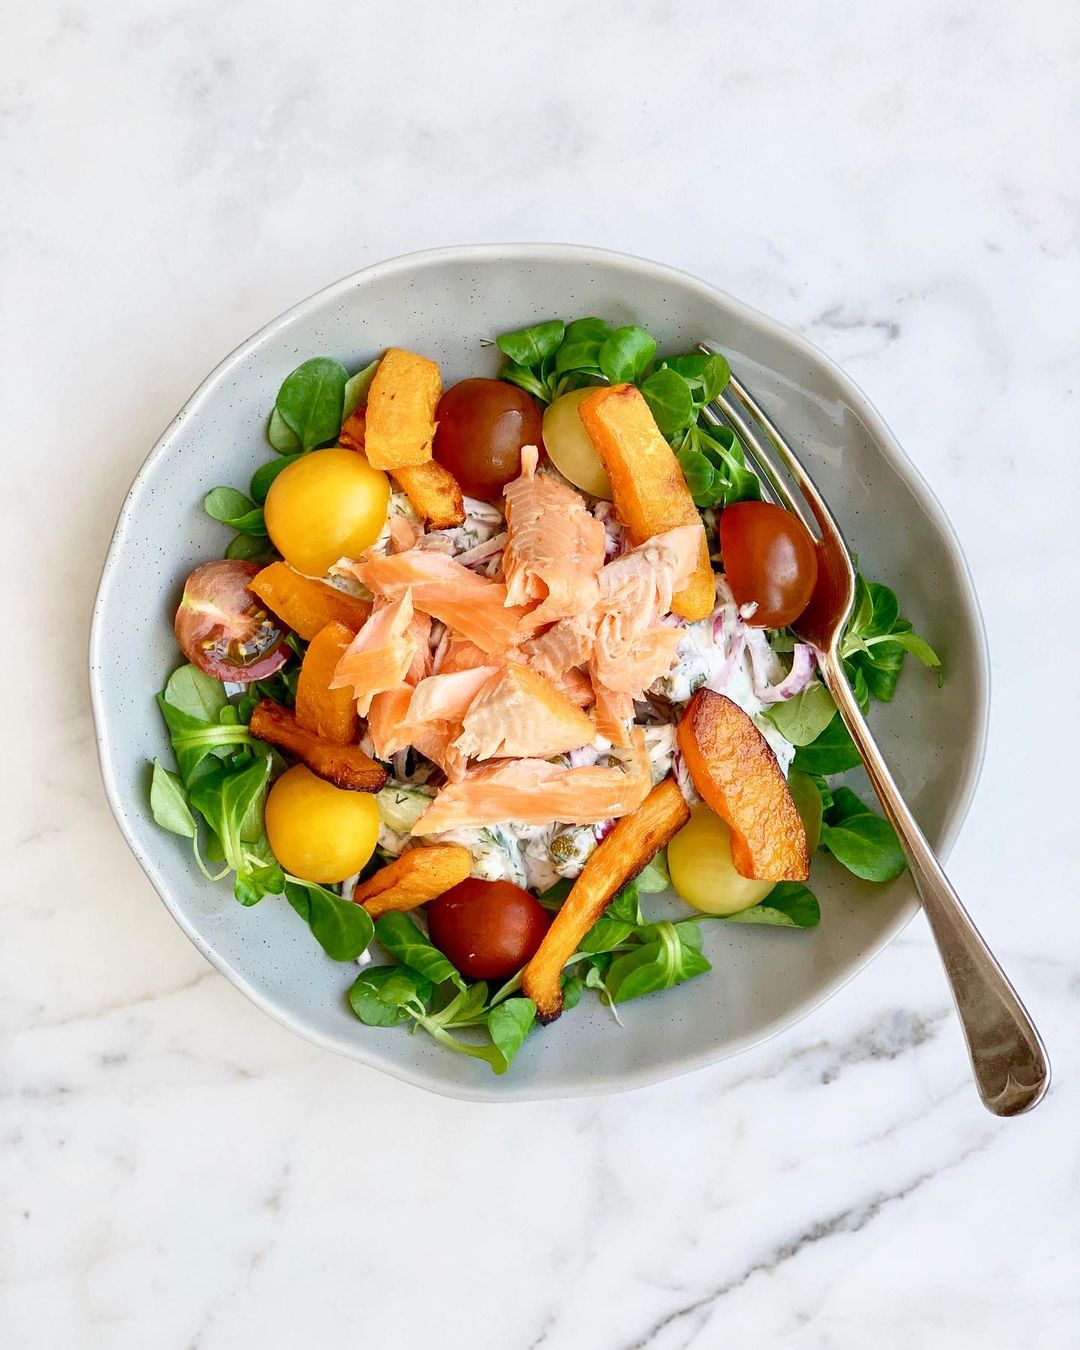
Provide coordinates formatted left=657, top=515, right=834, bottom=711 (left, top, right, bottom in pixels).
left=173, top=559, right=289, bottom=684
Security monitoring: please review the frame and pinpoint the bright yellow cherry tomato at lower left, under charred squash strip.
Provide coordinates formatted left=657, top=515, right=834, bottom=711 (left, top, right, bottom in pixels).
left=265, top=764, right=379, bottom=883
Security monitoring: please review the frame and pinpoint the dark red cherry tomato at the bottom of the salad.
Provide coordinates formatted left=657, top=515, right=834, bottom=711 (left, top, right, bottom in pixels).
left=428, top=876, right=551, bottom=980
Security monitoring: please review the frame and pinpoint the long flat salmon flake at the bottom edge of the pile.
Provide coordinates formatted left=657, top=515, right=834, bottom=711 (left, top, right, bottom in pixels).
left=413, top=728, right=652, bottom=834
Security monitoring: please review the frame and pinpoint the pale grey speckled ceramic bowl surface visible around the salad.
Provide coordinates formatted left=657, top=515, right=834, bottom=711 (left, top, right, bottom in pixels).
left=90, top=244, right=988, bottom=1102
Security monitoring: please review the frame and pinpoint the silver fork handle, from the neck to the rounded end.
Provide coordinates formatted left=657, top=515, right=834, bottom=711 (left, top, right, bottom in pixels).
left=818, top=649, right=1050, bottom=1115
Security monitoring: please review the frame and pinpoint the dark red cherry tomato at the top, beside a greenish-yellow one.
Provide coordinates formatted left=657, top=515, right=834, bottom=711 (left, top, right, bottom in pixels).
left=433, top=379, right=544, bottom=502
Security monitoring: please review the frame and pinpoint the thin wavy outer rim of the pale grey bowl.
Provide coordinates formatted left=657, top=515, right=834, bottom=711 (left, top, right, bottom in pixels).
left=88, top=243, right=991, bottom=1103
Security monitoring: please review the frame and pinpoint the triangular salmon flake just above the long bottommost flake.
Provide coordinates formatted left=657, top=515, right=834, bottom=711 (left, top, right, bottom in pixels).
left=446, top=662, right=595, bottom=760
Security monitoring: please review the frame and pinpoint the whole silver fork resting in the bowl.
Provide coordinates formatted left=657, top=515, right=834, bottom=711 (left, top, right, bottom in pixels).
left=698, top=342, right=1050, bottom=1115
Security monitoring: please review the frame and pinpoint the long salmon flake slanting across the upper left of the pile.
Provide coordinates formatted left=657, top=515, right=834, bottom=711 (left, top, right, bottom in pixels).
left=354, top=548, right=527, bottom=653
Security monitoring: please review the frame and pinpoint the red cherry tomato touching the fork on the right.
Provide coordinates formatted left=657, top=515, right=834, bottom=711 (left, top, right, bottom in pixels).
left=720, top=502, right=818, bottom=628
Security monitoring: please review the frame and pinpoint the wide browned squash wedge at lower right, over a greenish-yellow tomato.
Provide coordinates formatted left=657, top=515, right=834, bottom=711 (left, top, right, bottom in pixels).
left=678, top=689, right=810, bottom=882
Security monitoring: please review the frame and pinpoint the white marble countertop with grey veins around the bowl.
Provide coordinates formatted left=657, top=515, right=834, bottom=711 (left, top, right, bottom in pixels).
left=0, top=0, right=1080, bottom=1350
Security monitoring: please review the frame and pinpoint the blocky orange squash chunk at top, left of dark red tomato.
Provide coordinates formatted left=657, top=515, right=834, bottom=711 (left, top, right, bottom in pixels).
left=365, top=347, right=443, bottom=470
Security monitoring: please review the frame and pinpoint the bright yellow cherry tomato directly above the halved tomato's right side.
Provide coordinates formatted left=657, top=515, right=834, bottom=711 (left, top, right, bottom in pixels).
left=263, top=446, right=390, bottom=576
